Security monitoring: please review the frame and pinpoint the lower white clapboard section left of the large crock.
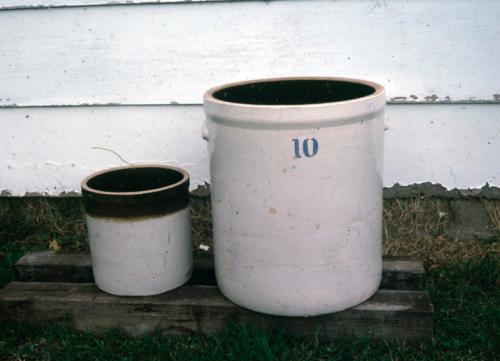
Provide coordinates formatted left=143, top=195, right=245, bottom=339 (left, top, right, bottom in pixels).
left=0, top=106, right=208, bottom=196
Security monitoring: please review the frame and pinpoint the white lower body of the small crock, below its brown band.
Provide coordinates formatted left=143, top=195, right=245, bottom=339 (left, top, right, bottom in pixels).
left=86, top=208, right=192, bottom=296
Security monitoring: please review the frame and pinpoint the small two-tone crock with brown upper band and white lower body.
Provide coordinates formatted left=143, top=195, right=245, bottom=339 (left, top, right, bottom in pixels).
left=82, top=165, right=192, bottom=296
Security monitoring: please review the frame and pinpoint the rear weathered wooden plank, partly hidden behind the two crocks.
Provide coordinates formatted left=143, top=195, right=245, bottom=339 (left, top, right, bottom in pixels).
left=14, top=252, right=425, bottom=290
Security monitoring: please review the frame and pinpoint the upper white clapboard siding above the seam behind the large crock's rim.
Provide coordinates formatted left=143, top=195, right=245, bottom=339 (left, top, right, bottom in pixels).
left=0, top=0, right=500, bottom=106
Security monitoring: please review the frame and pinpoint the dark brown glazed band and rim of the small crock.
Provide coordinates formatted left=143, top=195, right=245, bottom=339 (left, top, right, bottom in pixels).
left=81, top=164, right=189, bottom=218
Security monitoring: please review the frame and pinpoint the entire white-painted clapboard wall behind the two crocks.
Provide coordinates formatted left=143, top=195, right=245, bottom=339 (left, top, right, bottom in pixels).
left=0, top=0, right=500, bottom=196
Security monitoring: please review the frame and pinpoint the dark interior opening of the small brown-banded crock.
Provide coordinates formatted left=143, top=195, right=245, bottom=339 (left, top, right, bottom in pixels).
left=87, top=167, right=184, bottom=193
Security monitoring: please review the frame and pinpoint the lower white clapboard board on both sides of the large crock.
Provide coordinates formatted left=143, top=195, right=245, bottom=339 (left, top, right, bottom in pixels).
left=0, top=104, right=500, bottom=196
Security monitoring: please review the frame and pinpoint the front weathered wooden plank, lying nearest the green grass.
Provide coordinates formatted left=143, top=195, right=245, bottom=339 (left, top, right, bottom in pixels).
left=0, top=282, right=433, bottom=341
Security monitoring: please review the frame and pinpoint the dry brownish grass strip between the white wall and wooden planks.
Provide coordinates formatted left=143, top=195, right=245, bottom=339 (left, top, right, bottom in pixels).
left=0, top=197, right=500, bottom=266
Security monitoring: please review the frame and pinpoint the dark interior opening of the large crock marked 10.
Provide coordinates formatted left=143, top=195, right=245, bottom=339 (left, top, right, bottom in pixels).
left=213, top=79, right=375, bottom=105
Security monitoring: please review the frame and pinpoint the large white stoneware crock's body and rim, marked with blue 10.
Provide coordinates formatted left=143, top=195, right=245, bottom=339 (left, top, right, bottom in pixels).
left=204, top=78, right=385, bottom=316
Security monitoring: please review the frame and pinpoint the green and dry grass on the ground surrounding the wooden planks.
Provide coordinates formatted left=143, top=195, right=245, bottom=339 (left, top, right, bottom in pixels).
left=0, top=199, right=500, bottom=361
